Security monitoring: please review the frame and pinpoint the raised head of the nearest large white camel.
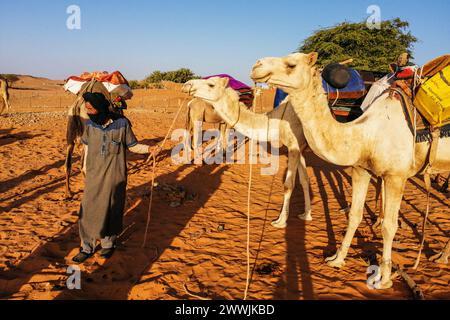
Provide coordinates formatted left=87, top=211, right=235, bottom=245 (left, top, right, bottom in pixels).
left=251, top=52, right=318, bottom=93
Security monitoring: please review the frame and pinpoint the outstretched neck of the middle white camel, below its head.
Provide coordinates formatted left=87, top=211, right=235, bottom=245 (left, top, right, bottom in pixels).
left=213, top=89, right=273, bottom=141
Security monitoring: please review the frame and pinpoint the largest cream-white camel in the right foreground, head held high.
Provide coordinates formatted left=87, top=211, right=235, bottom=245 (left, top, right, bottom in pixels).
left=252, top=53, right=450, bottom=289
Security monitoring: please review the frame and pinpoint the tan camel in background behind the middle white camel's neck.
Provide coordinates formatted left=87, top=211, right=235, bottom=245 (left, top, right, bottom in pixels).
left=186, top=98, right=227, bottom=160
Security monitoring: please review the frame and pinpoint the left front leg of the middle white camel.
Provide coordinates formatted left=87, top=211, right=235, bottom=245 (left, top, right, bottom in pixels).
left=272, top=150, right=300, bottom=229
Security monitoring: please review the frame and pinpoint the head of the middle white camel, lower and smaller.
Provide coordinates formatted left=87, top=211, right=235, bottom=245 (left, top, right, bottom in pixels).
left=183, top=77, right=230, bottom=103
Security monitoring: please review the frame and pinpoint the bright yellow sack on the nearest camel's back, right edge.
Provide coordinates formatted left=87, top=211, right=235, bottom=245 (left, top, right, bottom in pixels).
left=414, top=65, right=450, bottom=128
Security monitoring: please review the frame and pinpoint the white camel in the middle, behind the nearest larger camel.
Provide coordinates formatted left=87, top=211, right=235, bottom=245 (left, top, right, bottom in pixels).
left=183, top=77, right=312, bottom=228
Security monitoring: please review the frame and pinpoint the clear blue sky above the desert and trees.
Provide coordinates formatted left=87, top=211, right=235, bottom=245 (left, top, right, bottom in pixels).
left=0, top=0, right=450, bottom=82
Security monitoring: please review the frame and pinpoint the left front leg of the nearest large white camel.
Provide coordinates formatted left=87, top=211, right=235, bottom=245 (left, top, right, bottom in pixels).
left=326, top=168, right=371, bottom=268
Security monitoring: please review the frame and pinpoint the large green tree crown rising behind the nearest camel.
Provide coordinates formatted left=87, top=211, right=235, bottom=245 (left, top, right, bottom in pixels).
left=298, top=18, right=417, bottom=72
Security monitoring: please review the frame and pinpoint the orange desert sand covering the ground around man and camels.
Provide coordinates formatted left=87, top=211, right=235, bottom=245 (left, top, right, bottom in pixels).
left=0, top=77, right=450, bottom=299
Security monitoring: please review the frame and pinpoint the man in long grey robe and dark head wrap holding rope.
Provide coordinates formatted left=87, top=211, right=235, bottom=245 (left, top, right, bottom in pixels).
left=72, top=93, right=156, bottom=263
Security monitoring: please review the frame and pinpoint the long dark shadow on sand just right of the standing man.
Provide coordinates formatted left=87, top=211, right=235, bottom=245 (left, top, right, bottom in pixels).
left=52, top=165, right=228, bottom=300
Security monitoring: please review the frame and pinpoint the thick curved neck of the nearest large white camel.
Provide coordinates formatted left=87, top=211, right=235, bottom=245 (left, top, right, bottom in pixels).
left=290, top=70, right=362, bottom=166
